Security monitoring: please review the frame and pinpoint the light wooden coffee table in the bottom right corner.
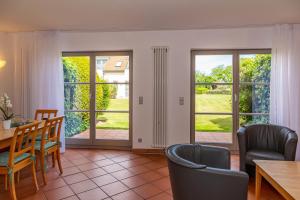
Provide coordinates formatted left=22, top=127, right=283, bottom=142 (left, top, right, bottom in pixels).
left=254, top=160, right=300, bottom=200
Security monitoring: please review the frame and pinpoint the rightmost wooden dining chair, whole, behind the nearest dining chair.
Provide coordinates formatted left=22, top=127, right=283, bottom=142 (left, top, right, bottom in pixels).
left=35, top=116, right=64, bottom=185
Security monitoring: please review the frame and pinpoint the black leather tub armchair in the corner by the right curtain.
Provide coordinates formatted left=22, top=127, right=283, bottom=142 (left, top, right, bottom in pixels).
left=237, top=124, right=298, bottom=175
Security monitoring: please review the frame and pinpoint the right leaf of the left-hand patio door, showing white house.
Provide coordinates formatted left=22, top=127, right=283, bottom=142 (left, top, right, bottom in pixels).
left=95, top=52, right=131, bottom=146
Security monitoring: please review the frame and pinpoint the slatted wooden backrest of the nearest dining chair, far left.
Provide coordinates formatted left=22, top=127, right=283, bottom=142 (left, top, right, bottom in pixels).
left=8, top=122, right=40, bottom=168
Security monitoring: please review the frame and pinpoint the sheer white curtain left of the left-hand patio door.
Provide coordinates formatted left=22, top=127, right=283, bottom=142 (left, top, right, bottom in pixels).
left=14, top=31, right=65, bottom=151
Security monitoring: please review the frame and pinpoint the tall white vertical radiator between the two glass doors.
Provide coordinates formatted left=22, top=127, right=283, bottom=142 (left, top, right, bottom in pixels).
left=153, top=47, right=168, bottom=148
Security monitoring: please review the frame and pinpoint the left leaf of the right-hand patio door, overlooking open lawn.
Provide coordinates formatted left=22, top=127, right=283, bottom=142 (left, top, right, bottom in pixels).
left=193, top=52, right=234, bottom=145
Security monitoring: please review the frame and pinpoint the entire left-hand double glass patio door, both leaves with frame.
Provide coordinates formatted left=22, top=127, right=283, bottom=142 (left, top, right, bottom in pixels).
left=62, top=51, right=132, bottom=148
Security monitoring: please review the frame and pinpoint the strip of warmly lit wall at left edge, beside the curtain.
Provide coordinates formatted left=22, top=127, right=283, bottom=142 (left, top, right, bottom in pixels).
left=0, top=32, right=14, bottom=103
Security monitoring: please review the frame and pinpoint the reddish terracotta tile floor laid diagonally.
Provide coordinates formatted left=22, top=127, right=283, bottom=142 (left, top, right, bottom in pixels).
left=0, top=149, right=282, bottom=200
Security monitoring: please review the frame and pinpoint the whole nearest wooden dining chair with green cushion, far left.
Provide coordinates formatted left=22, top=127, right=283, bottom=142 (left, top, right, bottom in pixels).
left=0, top=122, right=39, bottom=200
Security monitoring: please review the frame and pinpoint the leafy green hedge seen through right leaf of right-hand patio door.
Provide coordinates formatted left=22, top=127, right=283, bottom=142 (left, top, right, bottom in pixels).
left=239, top=54, right=271, bottom=123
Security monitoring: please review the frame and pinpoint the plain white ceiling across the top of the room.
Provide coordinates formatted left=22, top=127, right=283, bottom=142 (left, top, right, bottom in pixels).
left=0, top=0, right=300, bottom=32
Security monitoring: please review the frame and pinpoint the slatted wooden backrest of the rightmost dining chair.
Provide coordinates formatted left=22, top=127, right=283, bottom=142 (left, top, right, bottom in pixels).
left=41, top=116, right=64, bottom=149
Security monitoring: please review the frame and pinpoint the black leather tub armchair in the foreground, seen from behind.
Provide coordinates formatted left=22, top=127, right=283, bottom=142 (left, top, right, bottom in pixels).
left=166, top=144, right=248, bottom=200
